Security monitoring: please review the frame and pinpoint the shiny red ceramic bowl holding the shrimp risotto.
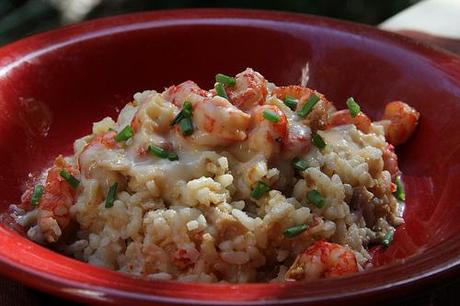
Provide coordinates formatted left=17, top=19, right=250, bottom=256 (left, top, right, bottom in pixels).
left=0, top=10, right=460, bottom=305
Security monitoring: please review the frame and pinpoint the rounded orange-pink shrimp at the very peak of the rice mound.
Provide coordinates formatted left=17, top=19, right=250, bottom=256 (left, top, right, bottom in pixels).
left=226, top=68, right=268, bottom=111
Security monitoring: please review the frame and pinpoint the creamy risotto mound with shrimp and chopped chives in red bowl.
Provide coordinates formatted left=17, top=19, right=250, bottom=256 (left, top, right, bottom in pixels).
left=10, top=68, right=419, bottom=283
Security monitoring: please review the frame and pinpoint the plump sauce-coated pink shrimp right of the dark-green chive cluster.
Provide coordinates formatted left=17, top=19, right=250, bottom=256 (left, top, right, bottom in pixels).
left=181, top=96, right=251, bottom=146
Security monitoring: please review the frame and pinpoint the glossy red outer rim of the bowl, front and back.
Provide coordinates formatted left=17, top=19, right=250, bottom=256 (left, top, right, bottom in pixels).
left=0, top=9, right=460, bottom=305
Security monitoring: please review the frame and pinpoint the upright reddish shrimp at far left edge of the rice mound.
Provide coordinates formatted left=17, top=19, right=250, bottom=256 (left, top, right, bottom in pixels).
left=37, top=156, right=79, bottom=243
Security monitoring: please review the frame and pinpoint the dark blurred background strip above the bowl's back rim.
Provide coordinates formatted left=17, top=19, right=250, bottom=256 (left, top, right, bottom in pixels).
left=0, top=0, right=424, bottom=45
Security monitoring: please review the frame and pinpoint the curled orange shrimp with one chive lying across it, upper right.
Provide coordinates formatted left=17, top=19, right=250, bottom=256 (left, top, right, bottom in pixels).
left=272, top=85, right=335, bottom=131
